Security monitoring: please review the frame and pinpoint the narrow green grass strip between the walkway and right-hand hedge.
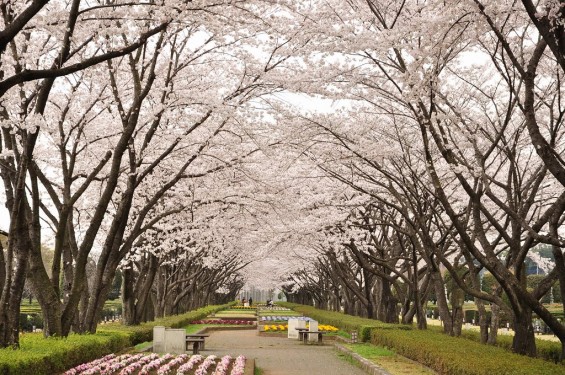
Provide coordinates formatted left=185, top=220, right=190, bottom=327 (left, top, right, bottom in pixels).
left=344, top=344, right=436, bottom=375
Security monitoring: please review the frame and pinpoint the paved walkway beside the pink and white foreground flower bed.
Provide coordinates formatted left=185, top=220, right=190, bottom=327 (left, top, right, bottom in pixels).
left=201, top=330, right=365, bottom=375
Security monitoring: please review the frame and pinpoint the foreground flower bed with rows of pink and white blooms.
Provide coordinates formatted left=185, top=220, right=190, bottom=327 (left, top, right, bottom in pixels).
left=64, top=353, right=246, bottom=375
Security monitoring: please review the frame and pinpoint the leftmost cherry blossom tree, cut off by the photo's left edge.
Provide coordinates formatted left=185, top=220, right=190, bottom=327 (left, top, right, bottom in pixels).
left=0, top=0, right=169, bottom=346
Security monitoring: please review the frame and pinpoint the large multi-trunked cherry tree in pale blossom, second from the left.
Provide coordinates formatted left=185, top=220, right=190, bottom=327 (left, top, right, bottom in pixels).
left=2, top=1, right=310, bottom=341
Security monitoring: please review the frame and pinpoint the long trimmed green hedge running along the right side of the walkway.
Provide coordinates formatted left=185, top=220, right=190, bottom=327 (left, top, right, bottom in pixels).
left=278, top=303, right=565, bottom=375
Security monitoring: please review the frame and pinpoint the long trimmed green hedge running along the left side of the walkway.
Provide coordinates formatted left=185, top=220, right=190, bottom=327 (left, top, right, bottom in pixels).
left=0, top=304, right=232, bottom=375
